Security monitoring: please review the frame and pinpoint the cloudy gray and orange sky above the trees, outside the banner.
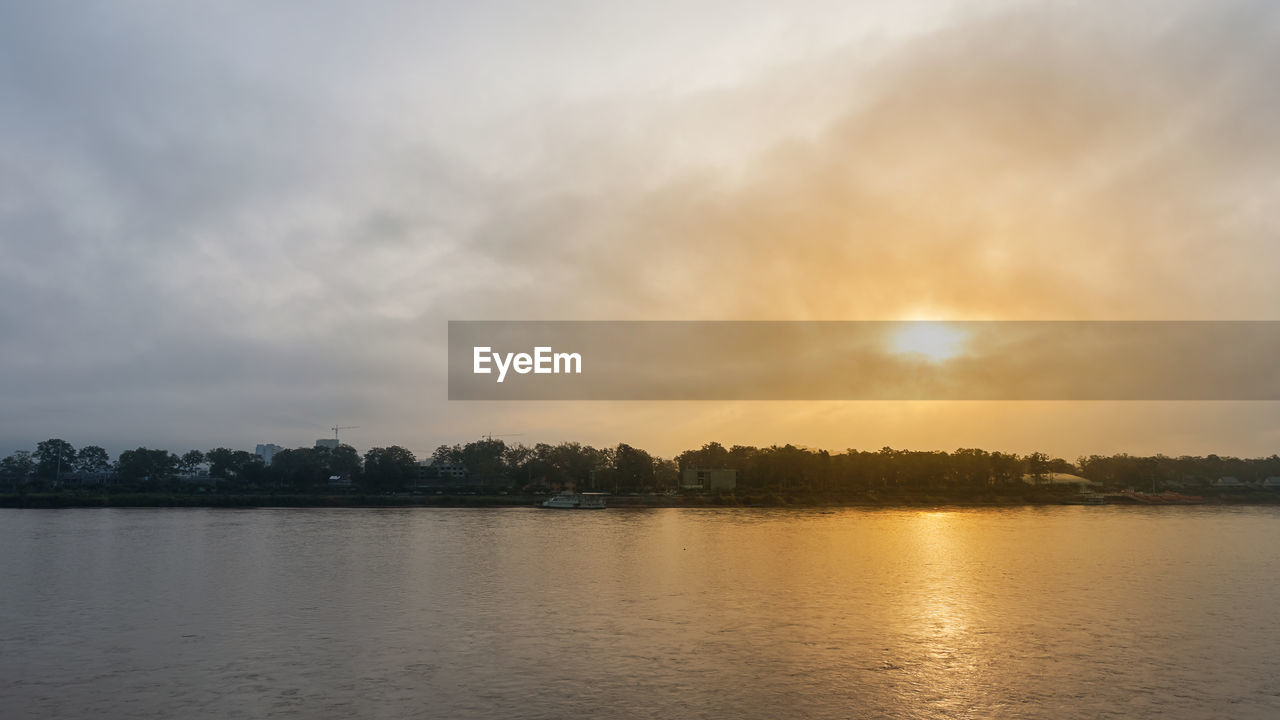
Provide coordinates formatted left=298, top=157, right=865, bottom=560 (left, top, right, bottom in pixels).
left=0, top=0, right=1280, bottom=459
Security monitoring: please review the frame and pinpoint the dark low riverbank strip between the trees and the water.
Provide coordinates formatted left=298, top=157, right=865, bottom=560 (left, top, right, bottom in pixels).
left=10, top=487, right=1280, bottom=509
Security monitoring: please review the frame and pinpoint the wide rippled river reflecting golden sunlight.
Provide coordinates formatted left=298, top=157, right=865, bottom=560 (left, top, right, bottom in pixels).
left=0, top=506, right=1280, bottom=720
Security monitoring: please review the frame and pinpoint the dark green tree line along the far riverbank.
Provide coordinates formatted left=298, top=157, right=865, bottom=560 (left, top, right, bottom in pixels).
left=0, top=438, right=1280, bottom=495
